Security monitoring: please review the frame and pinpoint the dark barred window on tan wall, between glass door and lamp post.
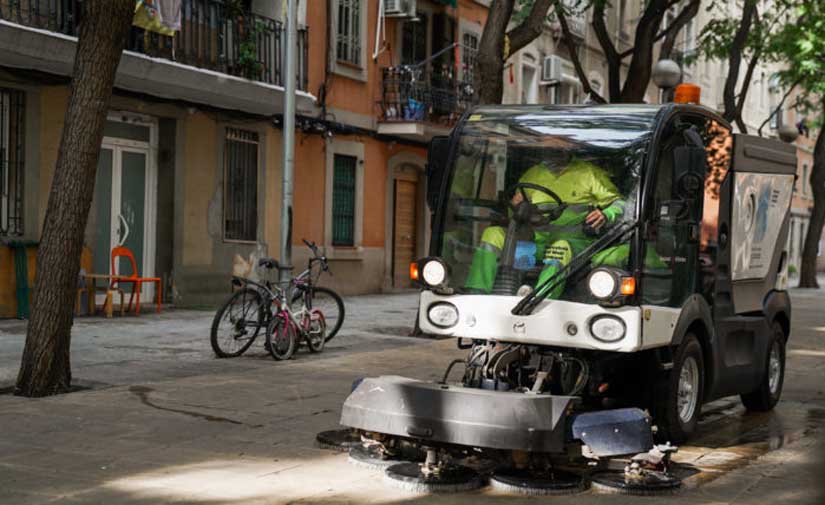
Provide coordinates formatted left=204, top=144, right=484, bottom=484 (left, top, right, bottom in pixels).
left=223, top=128, right=258, bottom=242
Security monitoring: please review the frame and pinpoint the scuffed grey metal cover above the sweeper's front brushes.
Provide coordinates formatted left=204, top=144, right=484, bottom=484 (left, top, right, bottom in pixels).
left=341, top=376, right=578, bottom=453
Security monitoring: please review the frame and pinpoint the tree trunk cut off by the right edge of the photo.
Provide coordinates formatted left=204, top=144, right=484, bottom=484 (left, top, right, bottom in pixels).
left=799, top=111, right=825, bottom=288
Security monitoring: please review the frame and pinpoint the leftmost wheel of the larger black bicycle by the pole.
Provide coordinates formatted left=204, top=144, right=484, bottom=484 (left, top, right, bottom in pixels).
left=209, top=288, right=264, bottom=358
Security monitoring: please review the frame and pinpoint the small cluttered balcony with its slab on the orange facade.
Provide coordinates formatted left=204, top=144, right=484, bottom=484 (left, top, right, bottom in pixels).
left=378, top=65, right=473, bottom=141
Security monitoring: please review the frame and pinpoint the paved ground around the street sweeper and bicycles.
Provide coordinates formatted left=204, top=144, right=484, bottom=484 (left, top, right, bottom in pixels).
left=0, top=290, right=825, bottom=505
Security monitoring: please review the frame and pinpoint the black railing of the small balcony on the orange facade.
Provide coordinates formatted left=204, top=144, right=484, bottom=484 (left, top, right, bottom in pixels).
left=380, top=66, right=473, bottom=125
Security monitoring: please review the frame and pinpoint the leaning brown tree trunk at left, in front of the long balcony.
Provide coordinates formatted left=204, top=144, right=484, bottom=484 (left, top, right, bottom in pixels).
left=15, top=0, right=135, bottom=396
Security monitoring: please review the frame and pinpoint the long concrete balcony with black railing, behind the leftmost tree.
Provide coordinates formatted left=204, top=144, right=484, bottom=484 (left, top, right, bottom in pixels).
left=0, top=0, right=313, bottom=114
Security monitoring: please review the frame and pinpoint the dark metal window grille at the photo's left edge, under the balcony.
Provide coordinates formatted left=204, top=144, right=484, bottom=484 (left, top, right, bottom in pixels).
left=0, top=88, right=25, bottom=237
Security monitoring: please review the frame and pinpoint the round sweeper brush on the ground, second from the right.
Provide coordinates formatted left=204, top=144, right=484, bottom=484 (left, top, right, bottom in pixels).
left=490, top=468, right=587, bottom=496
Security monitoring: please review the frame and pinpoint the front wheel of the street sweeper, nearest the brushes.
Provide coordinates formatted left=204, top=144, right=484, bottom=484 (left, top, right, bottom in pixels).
left=653, top=333, right=705, bottom=444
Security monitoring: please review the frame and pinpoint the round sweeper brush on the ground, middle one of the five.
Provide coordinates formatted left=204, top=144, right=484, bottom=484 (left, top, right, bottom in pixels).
left=384, top=463, right=481, bottom=493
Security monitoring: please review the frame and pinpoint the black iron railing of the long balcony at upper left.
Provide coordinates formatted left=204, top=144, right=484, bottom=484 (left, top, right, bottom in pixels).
left=0, top=0, right=308, bottom=90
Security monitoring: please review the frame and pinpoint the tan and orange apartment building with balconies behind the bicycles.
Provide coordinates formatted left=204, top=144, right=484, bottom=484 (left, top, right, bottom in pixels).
left=0, top=0, right=488, bottom=317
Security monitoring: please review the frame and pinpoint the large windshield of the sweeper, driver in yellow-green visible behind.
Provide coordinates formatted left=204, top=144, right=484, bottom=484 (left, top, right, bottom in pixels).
left=436, top=106, right=659, bottom=300
